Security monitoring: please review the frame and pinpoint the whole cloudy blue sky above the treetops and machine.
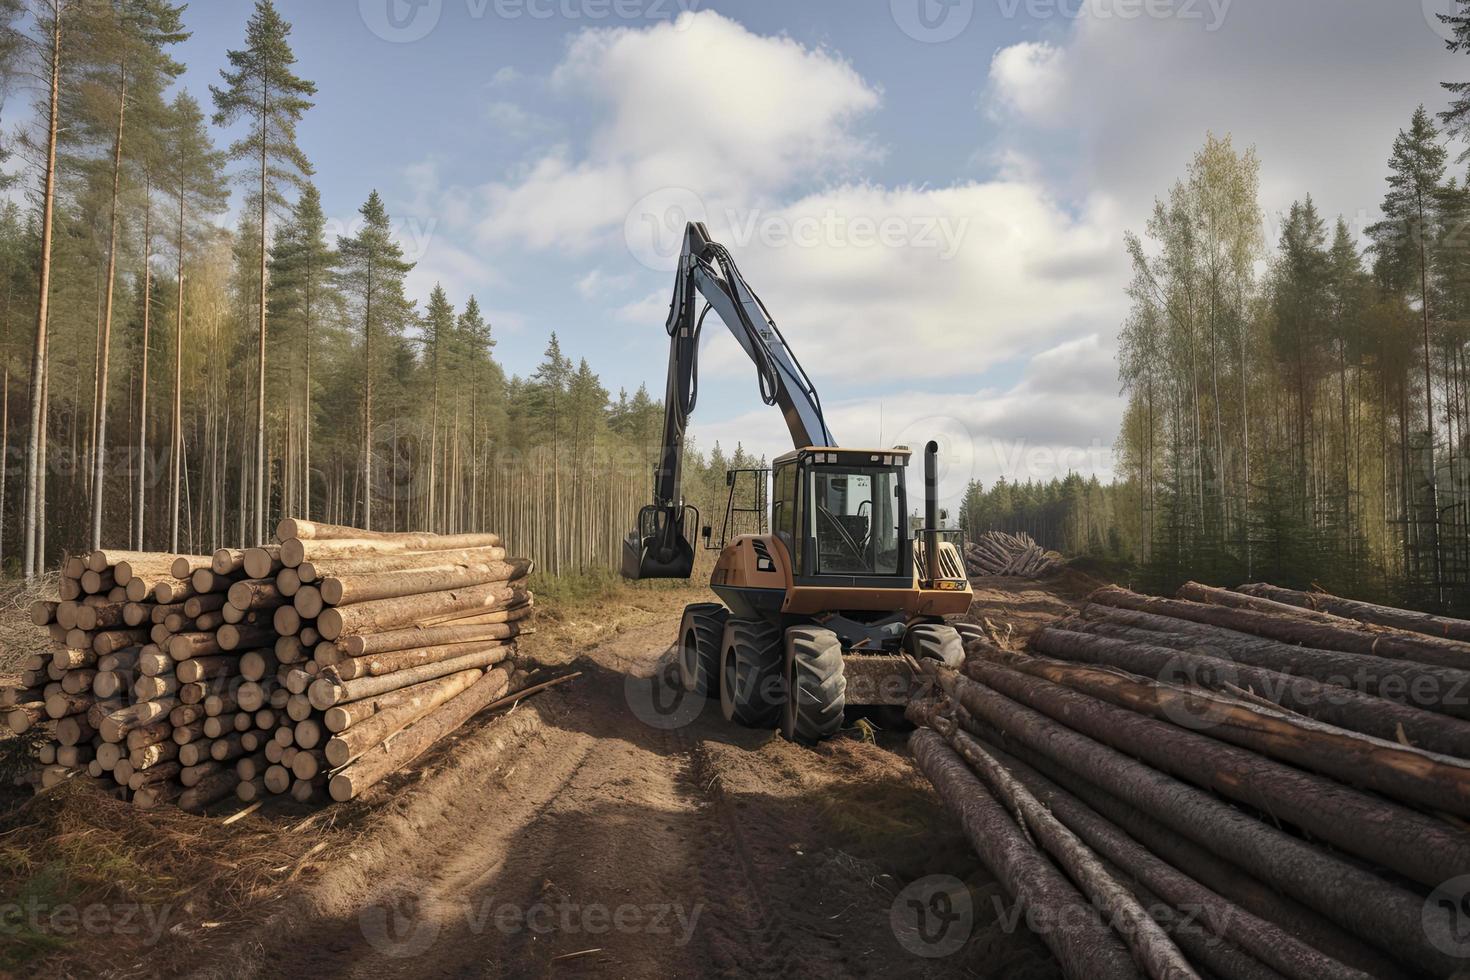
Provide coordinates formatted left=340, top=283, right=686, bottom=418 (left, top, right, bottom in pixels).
left=158, top=0, right=1470, bottom=514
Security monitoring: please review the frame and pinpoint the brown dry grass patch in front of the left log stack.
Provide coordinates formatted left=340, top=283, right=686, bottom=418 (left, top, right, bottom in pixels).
left=0, top=779, right=316, bottom=976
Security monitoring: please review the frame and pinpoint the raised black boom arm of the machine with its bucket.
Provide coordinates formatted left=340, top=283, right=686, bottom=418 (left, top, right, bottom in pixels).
left=623, top=222, right=836, bottom=579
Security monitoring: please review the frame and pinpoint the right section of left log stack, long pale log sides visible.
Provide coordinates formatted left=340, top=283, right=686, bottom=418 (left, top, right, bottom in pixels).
left=270, top=519, right=535, bottom=801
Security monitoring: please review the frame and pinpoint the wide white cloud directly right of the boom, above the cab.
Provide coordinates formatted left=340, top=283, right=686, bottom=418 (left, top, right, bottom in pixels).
left=696, top=181, right=1126, bottom=386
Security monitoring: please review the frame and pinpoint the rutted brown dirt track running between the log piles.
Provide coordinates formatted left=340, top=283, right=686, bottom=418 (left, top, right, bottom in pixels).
left=229, top=599, right=1054, bottom=977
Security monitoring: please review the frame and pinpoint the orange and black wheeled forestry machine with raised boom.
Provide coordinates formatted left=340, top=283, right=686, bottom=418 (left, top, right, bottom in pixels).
left=622, top=223, right=973, bottom=745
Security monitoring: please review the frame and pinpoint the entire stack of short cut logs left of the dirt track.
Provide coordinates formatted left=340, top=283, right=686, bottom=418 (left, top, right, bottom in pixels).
left=0, top=520, right=534, bottom=811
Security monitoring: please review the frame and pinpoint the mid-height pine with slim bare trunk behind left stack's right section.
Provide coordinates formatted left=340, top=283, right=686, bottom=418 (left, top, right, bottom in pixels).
left=337, top=191, right=415, bottom=530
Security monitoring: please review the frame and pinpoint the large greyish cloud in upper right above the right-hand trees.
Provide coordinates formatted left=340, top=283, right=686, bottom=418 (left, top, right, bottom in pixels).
left=988, top=0, right=1470, bottom=235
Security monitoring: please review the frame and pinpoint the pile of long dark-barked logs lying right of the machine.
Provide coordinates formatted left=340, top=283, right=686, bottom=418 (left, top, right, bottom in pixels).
left=908, top=583, right=1470, bottom=980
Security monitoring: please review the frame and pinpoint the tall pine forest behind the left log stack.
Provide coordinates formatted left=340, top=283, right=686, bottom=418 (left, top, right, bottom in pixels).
left=0, top=0, right=745, bottom=574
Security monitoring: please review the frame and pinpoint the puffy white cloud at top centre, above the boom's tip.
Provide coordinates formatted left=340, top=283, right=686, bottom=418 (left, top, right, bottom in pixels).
left=479, top=10, right=879, bottom=250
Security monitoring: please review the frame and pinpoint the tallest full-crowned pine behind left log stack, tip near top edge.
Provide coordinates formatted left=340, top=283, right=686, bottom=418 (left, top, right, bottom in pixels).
left=209, top=0, right=316, bottom=544
